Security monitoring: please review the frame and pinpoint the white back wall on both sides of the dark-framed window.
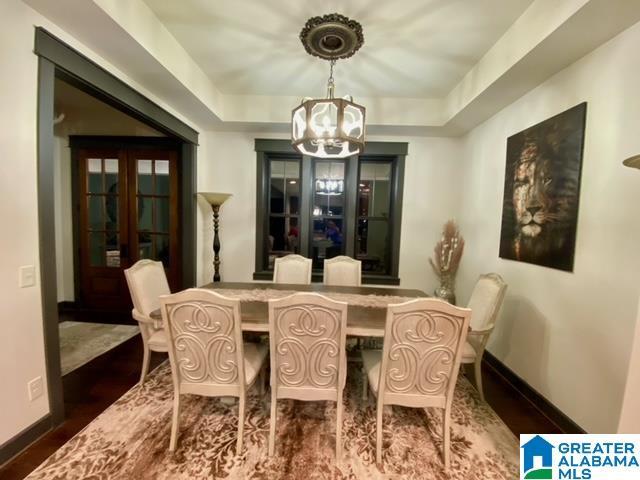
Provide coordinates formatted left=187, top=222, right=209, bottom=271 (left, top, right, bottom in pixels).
left=198, top=132, right=460, bottom=291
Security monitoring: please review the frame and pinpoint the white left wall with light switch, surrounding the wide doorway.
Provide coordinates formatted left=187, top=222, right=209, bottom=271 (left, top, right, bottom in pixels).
left=0, top=0, right=206, bottom=445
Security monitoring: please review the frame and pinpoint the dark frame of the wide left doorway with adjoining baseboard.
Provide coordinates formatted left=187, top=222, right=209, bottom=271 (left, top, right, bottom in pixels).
left=0, top=27, right=198, bottom=463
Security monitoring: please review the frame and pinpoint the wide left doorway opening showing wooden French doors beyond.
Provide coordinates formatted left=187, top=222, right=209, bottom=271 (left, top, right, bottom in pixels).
left=53, top=79, right=181, bottom=390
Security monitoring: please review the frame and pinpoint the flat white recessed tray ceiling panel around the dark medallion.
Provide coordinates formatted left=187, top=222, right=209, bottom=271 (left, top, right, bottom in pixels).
left=145, top=0, right=532, bottom=98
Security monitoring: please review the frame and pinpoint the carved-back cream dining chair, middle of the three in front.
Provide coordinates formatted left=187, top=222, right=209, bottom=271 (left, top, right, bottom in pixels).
left=269, top=293, right=347, bottom=462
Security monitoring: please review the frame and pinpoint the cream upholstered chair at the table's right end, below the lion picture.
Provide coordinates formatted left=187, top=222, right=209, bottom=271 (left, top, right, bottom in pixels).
left=462, top=273, right=507, bottom=401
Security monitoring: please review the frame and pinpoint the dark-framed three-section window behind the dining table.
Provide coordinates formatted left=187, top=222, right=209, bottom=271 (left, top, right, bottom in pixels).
left=254, top=140, right=407, bottom=285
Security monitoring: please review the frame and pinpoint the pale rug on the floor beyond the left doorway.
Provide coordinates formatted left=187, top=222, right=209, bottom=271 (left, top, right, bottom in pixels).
left=59, top=321, right=140, bottom=375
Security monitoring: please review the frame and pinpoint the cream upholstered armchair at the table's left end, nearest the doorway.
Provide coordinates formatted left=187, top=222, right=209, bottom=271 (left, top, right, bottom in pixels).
left=124, top=259, right=171, bottom=383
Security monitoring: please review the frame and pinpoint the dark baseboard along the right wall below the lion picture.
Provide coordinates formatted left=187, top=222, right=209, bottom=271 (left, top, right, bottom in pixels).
left=483, top=350, right=587, bottom=433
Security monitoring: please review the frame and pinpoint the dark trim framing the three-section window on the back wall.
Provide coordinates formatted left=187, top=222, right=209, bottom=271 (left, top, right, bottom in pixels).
left=253, top=138, right=409, bottom=285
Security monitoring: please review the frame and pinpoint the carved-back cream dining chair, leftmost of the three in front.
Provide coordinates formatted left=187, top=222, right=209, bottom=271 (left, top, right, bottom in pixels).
left=160, top=288, right=268, bottom=455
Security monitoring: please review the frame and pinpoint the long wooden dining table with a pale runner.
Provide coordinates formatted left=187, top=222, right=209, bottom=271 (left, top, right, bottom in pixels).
left=150, top=282, right=428, bottom=337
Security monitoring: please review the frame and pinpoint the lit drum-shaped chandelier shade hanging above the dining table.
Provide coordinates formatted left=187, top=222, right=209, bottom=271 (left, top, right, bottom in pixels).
left=291, top=97, right=365, bottom=158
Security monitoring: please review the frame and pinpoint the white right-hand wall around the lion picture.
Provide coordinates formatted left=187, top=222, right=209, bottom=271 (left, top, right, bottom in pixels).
left=459, top=20, right=640, bottom=432
